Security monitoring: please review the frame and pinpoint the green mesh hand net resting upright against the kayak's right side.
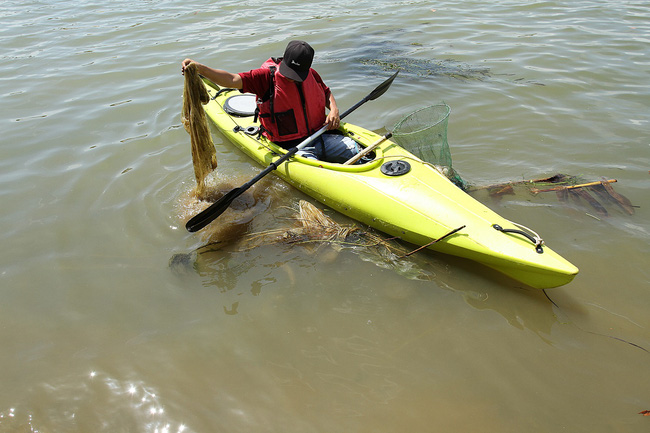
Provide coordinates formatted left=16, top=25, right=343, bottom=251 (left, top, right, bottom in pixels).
left=393, top=102, right=467, bottom=189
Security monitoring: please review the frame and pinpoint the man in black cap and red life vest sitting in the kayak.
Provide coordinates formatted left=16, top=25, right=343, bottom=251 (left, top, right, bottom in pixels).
left=181, top=41, right=359, bottom=163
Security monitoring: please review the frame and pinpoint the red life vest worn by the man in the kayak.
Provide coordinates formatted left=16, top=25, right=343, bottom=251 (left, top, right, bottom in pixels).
left=257, top=58, right=326, bottom=143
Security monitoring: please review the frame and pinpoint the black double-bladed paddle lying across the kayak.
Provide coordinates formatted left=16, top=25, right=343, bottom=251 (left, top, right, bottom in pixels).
left=185, top=71, right=399, bottom=232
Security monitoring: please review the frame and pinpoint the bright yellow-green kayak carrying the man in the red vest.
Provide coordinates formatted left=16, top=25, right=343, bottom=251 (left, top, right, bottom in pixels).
left=199, top=81, right=578, bottom=289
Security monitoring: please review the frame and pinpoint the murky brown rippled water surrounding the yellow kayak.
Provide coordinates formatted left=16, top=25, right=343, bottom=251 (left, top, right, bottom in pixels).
left=0, top=1, right=650, bottom=433
